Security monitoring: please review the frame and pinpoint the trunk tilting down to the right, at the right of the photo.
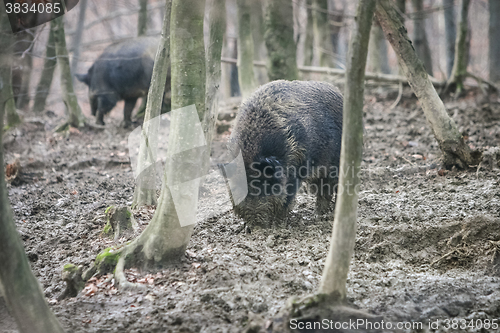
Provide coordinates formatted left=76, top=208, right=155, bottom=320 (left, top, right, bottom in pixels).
left=376, top=0, right=476, bottom=168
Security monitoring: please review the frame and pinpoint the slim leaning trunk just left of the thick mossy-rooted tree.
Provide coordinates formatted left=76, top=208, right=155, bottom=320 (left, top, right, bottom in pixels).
left=132, top=0, right=172, bottom=209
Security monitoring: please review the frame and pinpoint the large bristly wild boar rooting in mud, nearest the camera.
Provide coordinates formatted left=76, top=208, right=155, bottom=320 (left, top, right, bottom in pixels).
left=225, top=80, right=343, bottom=227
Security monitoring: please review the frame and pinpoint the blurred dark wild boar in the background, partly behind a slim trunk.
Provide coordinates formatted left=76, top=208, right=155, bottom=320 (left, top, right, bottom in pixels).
left=76, top=37, right=170, bottom=127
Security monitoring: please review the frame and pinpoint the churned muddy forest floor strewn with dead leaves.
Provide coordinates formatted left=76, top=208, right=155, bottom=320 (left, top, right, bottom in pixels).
left=0, top=87, right=500, bottom=333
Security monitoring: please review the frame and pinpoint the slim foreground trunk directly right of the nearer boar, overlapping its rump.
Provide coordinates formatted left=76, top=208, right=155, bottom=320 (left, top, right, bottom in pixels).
left=319, top=0, right=376, bottom=301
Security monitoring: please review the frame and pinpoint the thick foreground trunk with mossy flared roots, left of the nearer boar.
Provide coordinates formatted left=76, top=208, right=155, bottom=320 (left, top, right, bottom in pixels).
left=111, top=0, right=209, bottom=287
